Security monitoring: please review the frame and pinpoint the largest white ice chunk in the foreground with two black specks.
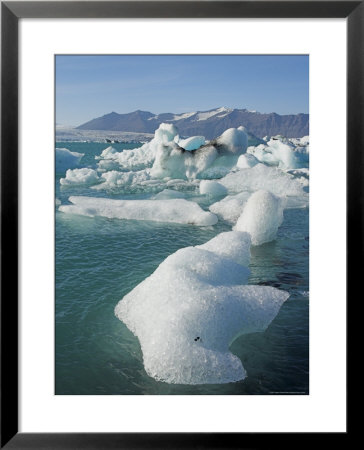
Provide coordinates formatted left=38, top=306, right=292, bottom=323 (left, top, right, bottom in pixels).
left=115, top=232, right=288, bottom=384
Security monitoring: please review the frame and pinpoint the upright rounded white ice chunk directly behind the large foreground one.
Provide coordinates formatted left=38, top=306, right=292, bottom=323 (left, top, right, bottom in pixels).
left=234, top=190, right=283, bottom=245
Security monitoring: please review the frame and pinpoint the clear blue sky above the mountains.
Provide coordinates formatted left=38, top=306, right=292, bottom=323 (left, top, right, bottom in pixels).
left=56, top=55, right=309, bottom=125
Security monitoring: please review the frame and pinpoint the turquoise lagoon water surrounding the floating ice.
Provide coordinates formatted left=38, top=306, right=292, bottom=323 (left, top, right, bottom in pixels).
left=55, top=143, right=309, bottom=395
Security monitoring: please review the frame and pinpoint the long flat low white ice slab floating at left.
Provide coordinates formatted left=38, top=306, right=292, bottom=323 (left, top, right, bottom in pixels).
left=59, top=196, right=217, bottom=226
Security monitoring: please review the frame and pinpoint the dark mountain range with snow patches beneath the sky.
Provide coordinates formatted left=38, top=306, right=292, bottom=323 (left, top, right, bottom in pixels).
left=77, top=107, right=309, bottom=139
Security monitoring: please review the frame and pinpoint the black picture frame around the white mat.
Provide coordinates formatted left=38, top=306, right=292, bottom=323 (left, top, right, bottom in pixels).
left=1, top=0, right=358, bottom=449
